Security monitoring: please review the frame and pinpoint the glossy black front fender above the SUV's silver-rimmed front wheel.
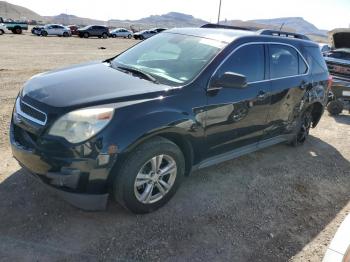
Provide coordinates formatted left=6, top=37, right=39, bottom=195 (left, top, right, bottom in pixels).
left=107, top=97, right=205, bottom=161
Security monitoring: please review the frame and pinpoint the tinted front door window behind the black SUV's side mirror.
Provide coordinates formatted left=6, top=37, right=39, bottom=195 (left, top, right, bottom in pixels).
left=219, top=45, right=265, bottom=82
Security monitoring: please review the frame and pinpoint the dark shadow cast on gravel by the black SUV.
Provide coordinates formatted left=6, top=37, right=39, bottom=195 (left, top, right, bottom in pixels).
left=0, top=136, right=350, bottom=261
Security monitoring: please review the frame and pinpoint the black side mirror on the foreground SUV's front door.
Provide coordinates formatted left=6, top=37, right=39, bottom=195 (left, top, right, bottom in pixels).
left=209, top=72, right=247, bottom=89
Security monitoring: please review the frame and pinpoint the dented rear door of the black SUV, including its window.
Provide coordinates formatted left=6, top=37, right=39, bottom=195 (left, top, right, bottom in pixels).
left=264, top=43, right=312, bottom=139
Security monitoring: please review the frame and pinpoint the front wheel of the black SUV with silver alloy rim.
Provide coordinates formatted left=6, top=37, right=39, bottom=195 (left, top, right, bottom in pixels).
left=113, top=137, right=185, bottom=214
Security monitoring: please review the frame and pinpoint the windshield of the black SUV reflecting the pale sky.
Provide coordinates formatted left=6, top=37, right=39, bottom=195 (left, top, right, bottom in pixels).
left=111, top=33, right=226, bottom=86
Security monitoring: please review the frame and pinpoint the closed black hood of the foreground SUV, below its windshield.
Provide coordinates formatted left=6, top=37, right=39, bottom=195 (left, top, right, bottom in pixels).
left=22, top=62, right=169, bottom=107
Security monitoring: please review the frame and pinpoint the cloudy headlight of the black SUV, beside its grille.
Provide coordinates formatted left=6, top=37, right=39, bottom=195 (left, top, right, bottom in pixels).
left=49, top=108, right=114, bottom=143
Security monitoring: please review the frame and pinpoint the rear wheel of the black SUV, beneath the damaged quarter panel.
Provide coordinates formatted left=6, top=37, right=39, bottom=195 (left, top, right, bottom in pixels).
left=290, top=106, right=312, bottom=147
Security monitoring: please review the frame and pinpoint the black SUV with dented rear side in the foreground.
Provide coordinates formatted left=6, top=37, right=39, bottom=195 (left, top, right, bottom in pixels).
left=10, top=28, right=329, bottom=213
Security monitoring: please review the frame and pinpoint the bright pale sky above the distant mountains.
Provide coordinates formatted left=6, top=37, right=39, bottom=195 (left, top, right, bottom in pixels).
left=8, top=0, right=350, bottom=29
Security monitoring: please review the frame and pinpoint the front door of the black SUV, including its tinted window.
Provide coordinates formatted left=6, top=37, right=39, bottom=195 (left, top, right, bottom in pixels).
left=205, top=43, right=270, bottom=157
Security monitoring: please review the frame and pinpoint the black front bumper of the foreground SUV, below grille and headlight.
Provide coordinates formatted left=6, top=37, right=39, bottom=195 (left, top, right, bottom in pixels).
left=10, top=114, right=116, bottom=210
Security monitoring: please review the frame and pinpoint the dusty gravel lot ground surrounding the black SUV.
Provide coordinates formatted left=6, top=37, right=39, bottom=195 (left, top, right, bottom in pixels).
left=0, top=31, right=350, bottom=261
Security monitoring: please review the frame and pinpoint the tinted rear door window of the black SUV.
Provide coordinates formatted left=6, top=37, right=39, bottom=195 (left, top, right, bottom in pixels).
left=269, top=45, right=299, bottom=79
